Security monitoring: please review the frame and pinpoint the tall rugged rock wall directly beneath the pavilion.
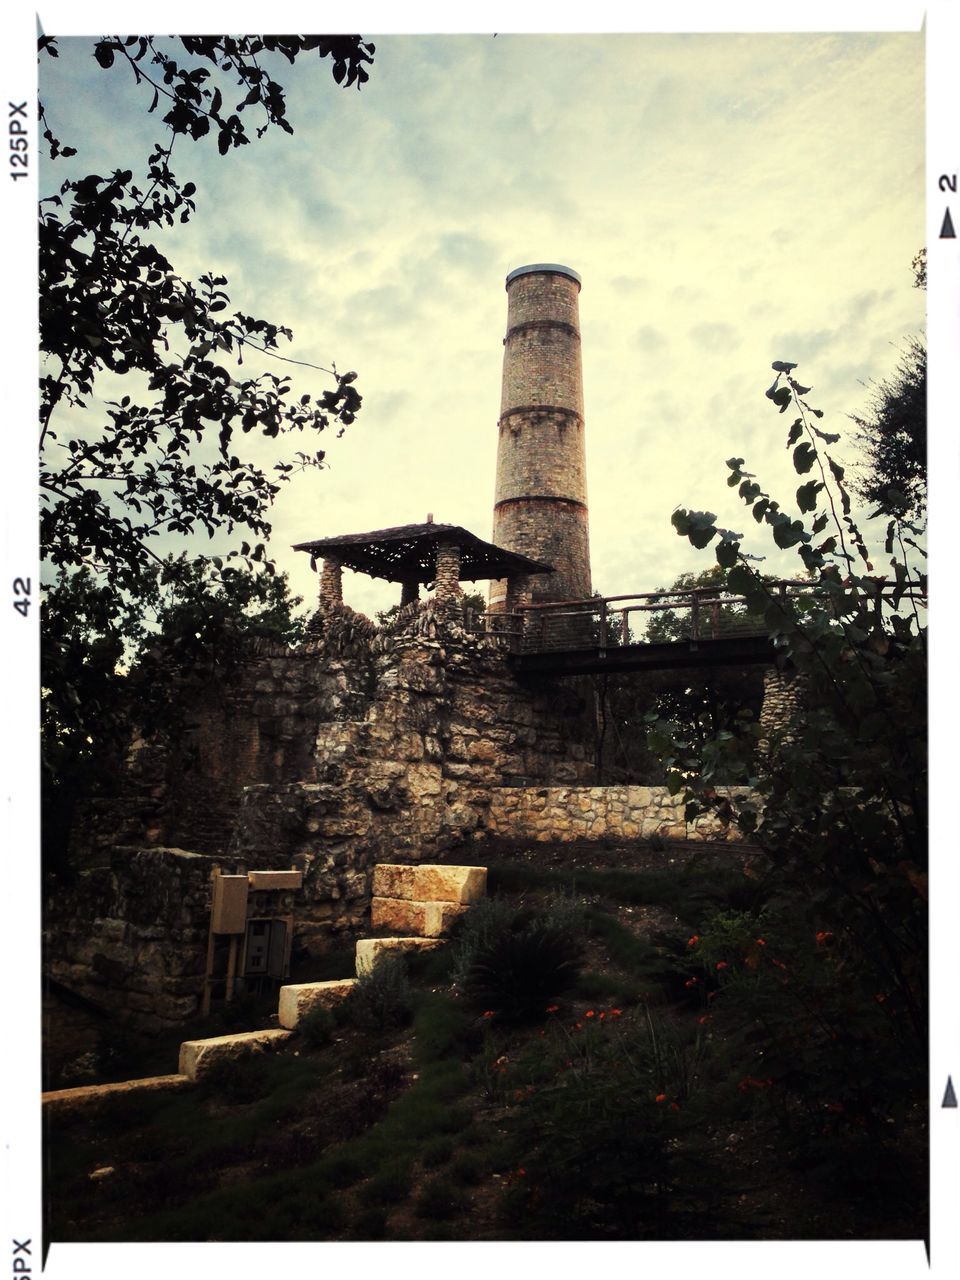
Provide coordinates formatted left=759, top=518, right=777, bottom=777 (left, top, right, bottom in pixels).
left=62, top=600, right=594, bottom=987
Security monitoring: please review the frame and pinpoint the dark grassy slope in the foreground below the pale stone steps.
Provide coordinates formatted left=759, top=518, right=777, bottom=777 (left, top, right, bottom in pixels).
left=47, top=844, right=926, bottom=1240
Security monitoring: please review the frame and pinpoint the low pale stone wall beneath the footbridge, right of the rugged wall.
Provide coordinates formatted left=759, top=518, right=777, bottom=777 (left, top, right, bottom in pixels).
left=484, top=786, right=749, bottom=841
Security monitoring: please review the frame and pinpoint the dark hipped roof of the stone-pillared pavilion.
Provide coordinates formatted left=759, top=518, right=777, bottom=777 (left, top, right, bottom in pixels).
left=293, top=522, right=553, bottom=582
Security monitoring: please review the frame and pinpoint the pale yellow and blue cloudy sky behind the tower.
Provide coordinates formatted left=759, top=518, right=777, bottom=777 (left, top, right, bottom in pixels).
left=33, top=13, right=925, bottom=612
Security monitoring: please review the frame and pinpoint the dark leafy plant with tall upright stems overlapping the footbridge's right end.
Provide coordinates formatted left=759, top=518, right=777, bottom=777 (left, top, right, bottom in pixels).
left=654, top=361, right=927, bottom=1052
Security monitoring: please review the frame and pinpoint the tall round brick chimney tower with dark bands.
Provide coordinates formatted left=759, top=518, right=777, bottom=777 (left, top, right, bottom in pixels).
left=489, top=262, right=591, bottom=613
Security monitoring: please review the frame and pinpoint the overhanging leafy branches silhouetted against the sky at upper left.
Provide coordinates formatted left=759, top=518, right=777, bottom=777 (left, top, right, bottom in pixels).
left=40, top=36, right=374, bottom=595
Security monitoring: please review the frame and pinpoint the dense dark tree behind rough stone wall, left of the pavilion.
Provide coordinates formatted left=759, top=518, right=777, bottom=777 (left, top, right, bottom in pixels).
left=41, top=558, right=305, bottom=872
